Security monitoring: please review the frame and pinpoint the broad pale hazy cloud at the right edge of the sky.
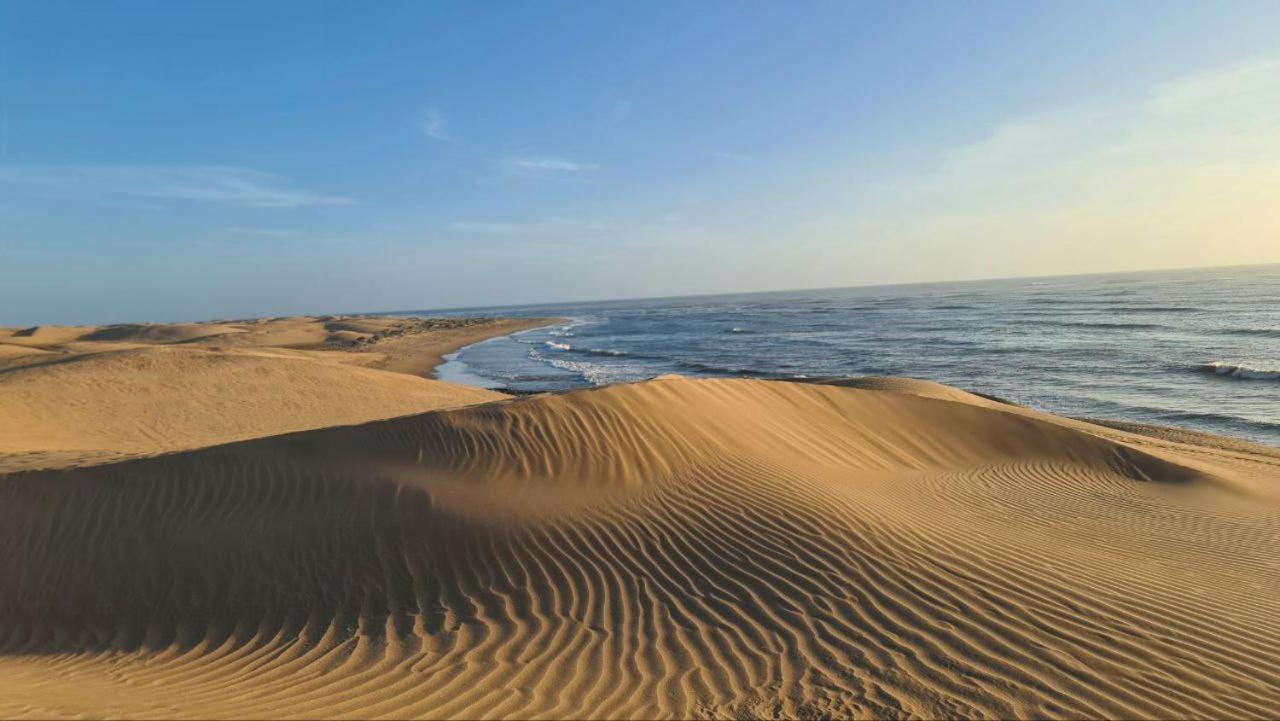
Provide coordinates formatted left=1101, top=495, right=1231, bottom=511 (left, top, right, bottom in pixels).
left=916, top=58, right=1280, bottom=205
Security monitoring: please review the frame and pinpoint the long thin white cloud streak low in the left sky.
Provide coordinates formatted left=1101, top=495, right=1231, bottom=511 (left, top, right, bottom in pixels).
left=0, top=165, right=356, bottom=209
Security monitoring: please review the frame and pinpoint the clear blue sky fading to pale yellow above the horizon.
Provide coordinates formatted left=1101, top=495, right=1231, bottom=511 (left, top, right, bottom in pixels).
left=0, top=0, right=1280, bottom=325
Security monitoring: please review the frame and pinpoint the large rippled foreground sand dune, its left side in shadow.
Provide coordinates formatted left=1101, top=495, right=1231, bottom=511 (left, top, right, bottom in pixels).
left=0, top=379, right=1280, bottom=717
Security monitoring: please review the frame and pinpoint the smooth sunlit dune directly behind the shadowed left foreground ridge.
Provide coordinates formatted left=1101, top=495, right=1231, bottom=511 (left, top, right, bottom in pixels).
left=0, top=346, right=504, bottom=471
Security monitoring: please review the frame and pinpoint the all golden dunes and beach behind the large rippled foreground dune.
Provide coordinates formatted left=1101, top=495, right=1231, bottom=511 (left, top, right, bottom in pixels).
left=0, top=318, right=543, bottom=473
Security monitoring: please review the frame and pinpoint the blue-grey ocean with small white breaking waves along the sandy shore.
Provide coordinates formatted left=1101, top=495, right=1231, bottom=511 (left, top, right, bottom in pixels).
left=412, top=265, right=1280, bottom=446
